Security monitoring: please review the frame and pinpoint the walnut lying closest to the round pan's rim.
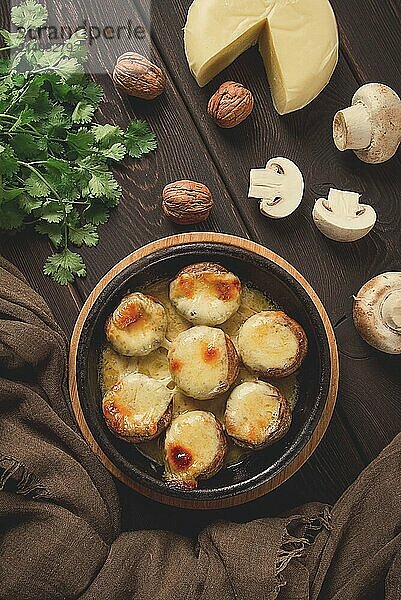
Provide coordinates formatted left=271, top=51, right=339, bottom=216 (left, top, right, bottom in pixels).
left=162, top=180, right=213, bottom=225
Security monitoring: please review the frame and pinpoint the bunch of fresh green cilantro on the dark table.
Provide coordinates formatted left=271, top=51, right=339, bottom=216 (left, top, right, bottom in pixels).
left=0, top=0, right=157, bottom=285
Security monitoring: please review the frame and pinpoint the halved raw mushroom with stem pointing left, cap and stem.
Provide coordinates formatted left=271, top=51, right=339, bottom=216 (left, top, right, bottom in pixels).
left=248, top=157, right=304, bottom=219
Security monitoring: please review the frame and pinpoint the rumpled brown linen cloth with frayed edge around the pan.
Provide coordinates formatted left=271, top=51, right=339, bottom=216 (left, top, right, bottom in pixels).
left=0, top=258, right=401, bottom=600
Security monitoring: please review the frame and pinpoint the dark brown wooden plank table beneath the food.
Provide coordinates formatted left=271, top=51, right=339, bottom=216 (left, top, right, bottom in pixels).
left=0, top=0, right=401, bottom=535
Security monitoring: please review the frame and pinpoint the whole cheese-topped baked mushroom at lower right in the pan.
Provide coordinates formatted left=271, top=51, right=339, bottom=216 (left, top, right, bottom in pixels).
left=224, top=381, right=292, bottom=450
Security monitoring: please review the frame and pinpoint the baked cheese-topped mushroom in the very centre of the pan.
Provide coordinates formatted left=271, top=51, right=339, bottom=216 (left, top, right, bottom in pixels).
left=168, top=326, right=239, bottom=400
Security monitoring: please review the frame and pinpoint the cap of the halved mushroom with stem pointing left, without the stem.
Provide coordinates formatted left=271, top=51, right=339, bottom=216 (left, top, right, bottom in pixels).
left=250, top=156, right=304, bottom=219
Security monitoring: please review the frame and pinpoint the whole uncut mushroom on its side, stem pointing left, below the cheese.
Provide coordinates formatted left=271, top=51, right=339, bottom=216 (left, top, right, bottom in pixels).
left=333, top=83, right=401, bottom=163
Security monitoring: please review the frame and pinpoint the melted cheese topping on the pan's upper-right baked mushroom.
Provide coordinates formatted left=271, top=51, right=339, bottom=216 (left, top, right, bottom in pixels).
left=238, top=311, right=299, bottom=373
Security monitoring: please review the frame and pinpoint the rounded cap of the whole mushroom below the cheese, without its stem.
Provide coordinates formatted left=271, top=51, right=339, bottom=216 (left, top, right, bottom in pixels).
left=352, top=83, right=401, bottom=163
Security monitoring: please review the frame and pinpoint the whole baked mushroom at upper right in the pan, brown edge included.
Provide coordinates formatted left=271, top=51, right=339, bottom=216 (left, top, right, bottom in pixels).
left=238, top=311, right=308, bottom=377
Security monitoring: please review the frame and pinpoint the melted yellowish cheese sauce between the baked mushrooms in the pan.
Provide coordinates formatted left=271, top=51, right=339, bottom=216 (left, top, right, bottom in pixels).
left=99, top=280, right=298, bottom=466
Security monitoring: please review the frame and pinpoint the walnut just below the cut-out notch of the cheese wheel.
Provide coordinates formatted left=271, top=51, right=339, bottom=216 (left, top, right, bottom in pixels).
left=207, top=81, right=254, bottom=129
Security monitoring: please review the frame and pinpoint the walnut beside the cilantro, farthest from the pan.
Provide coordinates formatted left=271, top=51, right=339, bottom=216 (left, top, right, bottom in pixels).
left=113, top=52, right=166, bottom=100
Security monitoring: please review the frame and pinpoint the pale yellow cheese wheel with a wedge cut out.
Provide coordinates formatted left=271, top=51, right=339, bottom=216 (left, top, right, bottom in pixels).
left=184, top=0, right=338, bottom=114
